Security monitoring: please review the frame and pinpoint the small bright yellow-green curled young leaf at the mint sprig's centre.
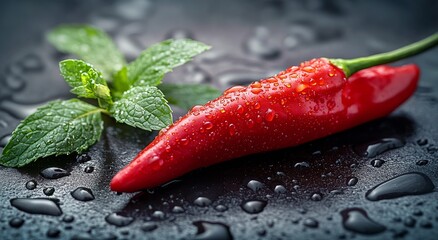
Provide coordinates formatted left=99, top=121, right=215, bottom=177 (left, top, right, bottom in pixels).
left=59, top=59, right=112, bottom=108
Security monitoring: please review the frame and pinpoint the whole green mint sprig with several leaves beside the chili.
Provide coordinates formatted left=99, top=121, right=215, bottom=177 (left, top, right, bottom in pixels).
left=0, top=25, right=219, bottom=167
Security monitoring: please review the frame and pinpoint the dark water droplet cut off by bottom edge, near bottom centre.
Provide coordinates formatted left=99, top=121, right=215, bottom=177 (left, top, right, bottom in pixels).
left=193, top=221, right=233, bottom=240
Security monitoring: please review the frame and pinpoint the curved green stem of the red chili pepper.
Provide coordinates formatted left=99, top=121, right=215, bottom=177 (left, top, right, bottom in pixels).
left=329, top=33, right=438, bottom=77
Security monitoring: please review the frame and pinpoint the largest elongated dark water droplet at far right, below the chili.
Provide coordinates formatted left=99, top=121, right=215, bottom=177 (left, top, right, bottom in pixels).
left=365, top=172, right=435, bottom=201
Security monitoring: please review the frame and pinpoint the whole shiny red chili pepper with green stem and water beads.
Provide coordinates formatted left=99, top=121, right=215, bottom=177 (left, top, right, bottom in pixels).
left=111, top=34, right=438, bottom=192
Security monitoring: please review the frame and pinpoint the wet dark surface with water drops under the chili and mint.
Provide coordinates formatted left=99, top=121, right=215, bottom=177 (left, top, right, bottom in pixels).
left=0, top=0, right=438, bottom=239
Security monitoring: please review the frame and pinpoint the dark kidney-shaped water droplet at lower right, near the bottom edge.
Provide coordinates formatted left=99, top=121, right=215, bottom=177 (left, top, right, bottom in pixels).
left=341, top=208, right=386, bottom=235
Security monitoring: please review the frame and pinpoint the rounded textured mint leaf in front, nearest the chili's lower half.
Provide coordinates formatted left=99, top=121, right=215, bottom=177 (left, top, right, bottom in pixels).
left=111, top=86, right=172, bottom=131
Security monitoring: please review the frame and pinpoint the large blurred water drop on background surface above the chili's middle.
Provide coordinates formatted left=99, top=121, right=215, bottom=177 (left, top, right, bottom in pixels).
left=244, top=27, right=280, bottom=59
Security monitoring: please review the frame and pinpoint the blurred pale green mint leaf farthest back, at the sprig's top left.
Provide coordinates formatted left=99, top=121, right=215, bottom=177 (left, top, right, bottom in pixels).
left=47, top=25, right=126, bottom=80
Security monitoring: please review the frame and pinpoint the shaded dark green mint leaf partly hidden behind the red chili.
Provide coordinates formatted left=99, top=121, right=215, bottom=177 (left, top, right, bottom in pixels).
left=159, top=83, right=221, bottom=110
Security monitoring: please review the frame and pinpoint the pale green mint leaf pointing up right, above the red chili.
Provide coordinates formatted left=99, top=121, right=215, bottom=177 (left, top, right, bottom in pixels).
left=128, top=39, right=210, bottom=86
